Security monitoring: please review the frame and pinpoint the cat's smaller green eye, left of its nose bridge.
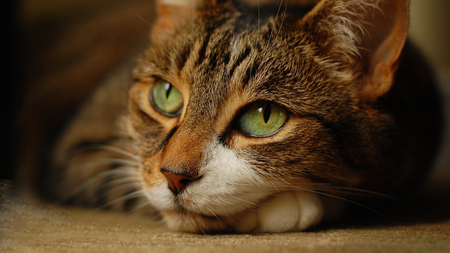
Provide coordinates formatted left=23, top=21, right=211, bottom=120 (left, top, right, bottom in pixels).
left=150, top=79, right=183, bottom=117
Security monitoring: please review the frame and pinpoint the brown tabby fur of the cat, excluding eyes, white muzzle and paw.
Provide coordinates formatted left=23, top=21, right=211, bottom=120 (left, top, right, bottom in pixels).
left=22, top=0, right=442, bottom=233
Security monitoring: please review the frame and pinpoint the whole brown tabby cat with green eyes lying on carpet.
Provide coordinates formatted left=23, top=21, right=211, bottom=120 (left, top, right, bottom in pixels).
left=29, top=0, right=442, bottom=233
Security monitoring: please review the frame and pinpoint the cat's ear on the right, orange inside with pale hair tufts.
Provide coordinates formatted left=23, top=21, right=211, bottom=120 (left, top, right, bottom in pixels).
left=303, top=0, right=409, bottom=100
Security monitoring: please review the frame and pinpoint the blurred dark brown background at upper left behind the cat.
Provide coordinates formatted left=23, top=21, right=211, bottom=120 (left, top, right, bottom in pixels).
left=0, top=0, right=155, bottom=184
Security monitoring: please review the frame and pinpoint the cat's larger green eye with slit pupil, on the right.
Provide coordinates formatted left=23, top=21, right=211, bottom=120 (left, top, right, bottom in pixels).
left=239, top=101, right=288, bottom=137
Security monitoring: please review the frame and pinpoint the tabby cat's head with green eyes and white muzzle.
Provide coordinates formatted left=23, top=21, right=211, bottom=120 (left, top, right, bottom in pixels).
left=128, top=0, right=409, bottom=231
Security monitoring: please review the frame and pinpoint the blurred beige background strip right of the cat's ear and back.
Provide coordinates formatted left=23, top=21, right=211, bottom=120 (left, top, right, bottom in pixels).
left=410, top=0, right=450, bottom=187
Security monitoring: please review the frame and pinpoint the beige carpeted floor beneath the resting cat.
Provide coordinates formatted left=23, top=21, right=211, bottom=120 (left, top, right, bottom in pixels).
left=0, top=182, right=450, bottom=253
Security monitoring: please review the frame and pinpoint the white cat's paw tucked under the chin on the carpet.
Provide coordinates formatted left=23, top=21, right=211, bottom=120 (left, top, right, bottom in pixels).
left=234, top=191, right=324, bottom=232
